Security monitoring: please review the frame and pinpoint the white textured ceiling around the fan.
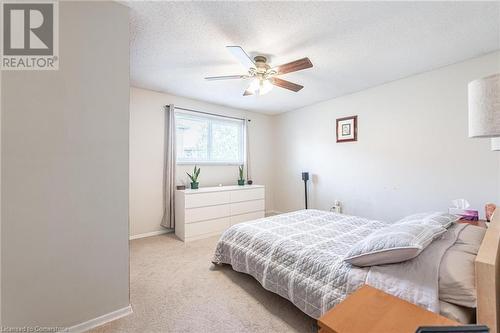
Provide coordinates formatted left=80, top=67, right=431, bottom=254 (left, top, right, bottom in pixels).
left=129, top=2, right=500, bottom=113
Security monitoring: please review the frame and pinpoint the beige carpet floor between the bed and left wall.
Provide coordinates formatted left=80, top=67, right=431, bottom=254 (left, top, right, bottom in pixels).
left=92, top=234, right=317, bottom=333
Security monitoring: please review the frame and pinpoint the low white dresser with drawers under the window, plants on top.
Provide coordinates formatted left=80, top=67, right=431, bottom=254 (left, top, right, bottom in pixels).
left=175, top=185, right=265, bottom=242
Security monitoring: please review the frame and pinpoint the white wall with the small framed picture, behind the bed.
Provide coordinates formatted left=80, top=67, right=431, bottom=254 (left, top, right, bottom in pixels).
left=273, top=52, right=500, bottom=220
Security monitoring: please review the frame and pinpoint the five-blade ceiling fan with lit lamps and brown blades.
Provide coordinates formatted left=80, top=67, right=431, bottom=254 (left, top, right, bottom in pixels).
left=205, top=46, right=313, bottom=96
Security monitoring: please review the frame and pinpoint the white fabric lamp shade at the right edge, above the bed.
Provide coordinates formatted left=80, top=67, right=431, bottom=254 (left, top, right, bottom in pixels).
left=469, top=74, right=500, bottom=138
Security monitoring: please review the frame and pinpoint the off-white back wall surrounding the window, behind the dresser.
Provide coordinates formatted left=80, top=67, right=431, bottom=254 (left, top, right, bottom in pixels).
left=130, top=87, right=273, bottom=236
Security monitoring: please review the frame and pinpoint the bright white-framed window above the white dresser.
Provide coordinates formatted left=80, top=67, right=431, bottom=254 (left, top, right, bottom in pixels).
left=175, top=111, right=245, bottom=165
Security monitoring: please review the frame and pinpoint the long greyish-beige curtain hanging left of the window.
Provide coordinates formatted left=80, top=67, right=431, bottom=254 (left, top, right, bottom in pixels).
left=161, top=104, right=176, bottom=229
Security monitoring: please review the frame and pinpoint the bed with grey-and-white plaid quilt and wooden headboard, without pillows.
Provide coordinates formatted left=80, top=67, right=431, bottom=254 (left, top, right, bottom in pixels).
left=213, top=210, right=500, bottom=332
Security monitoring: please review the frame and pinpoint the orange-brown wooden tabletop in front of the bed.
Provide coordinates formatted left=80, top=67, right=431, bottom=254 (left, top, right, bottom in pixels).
left=318, top=285, right=460, bottom=333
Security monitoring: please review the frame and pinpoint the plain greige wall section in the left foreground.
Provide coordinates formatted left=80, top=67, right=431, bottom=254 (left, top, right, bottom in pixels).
left=1, top=1, right=129, bottom=327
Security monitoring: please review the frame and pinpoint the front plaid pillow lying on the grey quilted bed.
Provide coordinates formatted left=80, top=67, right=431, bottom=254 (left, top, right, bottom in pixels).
left=344, top=220, right=446, bottom=266
